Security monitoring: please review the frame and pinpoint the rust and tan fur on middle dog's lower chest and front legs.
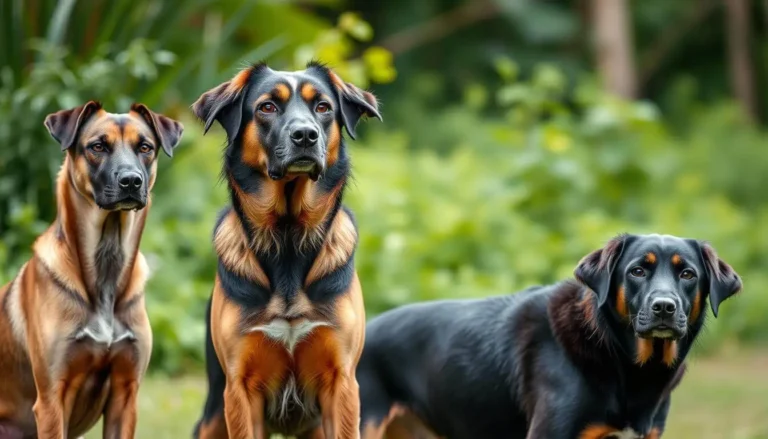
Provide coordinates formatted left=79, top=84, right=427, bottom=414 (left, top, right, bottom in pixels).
left=210, top=276, right=365, bottom=439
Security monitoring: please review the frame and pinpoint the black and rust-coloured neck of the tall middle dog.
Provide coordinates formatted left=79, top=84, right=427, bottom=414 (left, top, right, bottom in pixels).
left=224, top=150, right=349, bottom=254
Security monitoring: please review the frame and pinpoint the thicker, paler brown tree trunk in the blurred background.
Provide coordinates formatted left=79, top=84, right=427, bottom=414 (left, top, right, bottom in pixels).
left=591, top=0, right=637, bottom=99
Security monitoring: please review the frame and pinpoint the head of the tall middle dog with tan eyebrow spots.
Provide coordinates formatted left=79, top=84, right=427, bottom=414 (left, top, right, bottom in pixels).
left=192, top=63, right=381, bottom=180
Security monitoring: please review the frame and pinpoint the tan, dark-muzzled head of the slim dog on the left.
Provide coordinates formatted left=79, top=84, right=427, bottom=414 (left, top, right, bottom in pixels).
left=45, top=101, right=184, bottom=211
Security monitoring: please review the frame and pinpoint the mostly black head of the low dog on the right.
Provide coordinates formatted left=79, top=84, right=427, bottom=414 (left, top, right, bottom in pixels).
left=574, top=235, right=742, bottom=339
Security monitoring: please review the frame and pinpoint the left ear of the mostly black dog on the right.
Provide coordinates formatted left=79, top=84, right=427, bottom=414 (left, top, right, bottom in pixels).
left=573, top=235, right=632, bottom=306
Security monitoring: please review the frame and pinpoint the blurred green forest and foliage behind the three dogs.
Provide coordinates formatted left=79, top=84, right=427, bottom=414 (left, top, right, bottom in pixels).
left=0, top=0, right=768, bottom=438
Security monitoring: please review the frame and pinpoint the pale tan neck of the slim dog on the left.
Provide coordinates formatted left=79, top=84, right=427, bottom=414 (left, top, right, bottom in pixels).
left=35, top=155, right=149, bottom=312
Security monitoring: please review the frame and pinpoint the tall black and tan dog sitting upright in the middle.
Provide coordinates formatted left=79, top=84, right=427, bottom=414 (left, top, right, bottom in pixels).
left=194, top=64, right=380, bottom=439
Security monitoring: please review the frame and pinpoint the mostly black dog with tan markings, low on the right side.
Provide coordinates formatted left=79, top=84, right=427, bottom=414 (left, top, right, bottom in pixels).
left=357, top=235, right=741, bottom=439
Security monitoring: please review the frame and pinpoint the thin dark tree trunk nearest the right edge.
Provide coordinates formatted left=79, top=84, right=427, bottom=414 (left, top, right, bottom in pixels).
left=725, top=0, right=757, bottom=121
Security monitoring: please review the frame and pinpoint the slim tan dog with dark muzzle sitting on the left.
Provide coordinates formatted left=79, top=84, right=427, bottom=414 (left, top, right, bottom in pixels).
left=0, top=101, right=183, bottom=439
